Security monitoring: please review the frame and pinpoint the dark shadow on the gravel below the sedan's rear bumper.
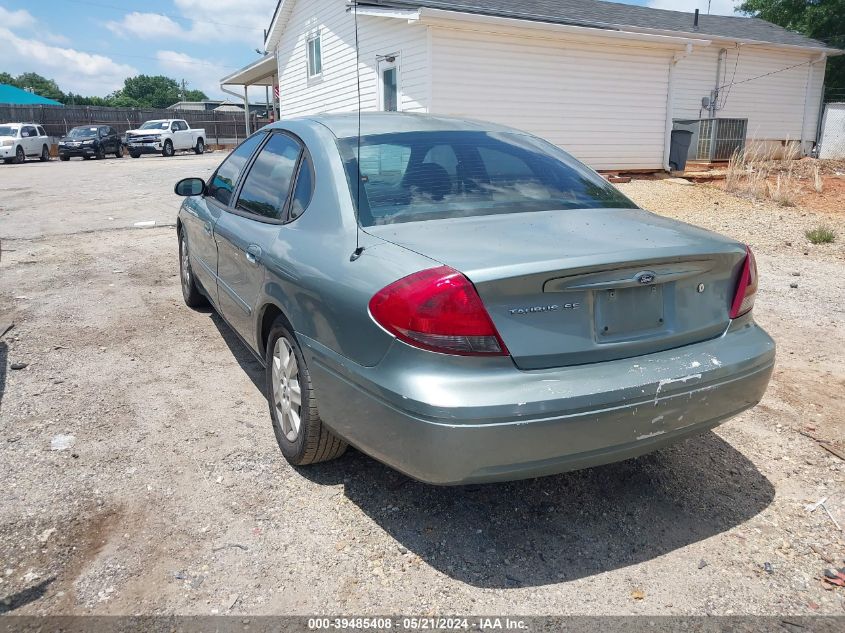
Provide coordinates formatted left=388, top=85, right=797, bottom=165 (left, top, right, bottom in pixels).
left=298, top=432, right=774, bottom=588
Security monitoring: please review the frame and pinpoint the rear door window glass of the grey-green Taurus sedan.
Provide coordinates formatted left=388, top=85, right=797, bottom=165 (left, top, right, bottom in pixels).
left=237, top=134, right=302, bottom=220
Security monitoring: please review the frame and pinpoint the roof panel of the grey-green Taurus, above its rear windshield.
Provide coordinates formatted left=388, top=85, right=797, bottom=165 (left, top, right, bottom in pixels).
left=268, top=112, right=517, bottom=138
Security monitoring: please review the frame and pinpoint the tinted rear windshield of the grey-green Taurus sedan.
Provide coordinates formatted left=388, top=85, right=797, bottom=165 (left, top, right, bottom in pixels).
left=338, top=131, right=636, bottom=226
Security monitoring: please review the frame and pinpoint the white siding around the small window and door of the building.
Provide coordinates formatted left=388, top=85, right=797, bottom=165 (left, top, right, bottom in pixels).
left=277, top=0, right=428, bottom=117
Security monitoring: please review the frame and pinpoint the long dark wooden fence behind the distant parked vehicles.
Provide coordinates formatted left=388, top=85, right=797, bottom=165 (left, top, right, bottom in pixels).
left=0, top=104, right=269, bottom=145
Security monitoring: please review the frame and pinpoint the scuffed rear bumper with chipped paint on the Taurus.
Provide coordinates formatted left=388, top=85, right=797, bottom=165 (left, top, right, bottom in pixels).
left=303, top=319, right=775, bottom=484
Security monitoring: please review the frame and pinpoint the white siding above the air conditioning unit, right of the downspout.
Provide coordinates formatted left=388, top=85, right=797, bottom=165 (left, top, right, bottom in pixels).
left=673, top=42, right=824, bottom=141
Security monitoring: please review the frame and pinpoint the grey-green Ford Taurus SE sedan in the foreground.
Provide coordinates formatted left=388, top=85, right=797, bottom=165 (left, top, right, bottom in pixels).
left=175, top=113, right=775, bottom=484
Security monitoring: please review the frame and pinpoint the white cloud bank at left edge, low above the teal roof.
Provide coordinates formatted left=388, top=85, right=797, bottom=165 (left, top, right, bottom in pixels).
left=0, top=28, right=138, bottom=95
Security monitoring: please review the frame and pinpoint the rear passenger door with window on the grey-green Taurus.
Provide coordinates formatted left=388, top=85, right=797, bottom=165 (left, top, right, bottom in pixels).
left=214, top=131, right=303, bottom=349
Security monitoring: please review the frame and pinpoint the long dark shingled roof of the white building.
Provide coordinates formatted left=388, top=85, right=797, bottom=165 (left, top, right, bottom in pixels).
left=359, top=0, right=832, bottom=49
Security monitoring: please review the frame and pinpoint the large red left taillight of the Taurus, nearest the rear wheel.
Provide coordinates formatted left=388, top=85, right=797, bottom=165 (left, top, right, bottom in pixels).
left=370, top=266, right=508, bottom=356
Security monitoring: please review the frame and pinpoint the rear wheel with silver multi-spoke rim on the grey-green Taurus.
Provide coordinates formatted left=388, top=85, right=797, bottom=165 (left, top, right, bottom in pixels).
left=265, top=318, right=347, bottom=466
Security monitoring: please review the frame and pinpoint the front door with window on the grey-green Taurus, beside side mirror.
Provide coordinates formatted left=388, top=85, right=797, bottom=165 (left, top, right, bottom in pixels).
left=182, top=133, right=266, bottom=305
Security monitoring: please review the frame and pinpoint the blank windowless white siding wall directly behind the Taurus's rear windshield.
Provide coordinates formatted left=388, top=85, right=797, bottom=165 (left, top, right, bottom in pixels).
left=432, top=28, right=674, bottom=169
